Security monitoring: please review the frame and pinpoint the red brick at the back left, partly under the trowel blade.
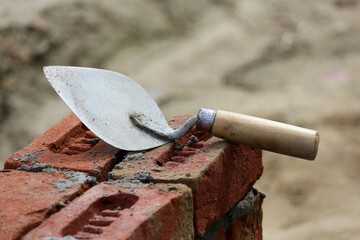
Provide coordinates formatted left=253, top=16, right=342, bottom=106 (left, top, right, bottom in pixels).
left=4, top=114, right=122, bottom=181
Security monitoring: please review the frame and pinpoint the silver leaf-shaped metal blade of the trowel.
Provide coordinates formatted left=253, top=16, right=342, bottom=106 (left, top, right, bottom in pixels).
left=44, top=66, right=170, bottom=151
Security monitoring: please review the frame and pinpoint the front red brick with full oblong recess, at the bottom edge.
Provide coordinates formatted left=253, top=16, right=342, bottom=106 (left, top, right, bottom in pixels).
left=24, top=183, right=194, bottom=240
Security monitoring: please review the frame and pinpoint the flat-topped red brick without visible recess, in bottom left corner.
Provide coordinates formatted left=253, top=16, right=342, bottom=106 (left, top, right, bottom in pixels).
left=0, top=170, right=90, bottom=239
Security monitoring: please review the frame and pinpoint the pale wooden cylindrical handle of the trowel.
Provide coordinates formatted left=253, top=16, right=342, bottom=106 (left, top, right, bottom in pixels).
left=211, top=110, right=319, bottom=160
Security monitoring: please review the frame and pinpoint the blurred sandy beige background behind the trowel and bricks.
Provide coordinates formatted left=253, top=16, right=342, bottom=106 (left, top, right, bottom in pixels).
left=0, top=0, right=360, bottom=239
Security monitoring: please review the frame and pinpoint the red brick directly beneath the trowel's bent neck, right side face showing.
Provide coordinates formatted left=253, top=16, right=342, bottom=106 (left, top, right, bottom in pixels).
left=111, top=117, right=263, bottom=236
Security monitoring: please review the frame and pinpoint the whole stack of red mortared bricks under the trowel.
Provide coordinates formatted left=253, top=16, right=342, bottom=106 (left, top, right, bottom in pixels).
left=0, top=115, right=263, bottom=240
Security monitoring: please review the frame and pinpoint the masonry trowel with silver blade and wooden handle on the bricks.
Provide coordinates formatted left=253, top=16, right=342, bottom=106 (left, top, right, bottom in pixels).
left=44, top=66, right=319, bottom=160
